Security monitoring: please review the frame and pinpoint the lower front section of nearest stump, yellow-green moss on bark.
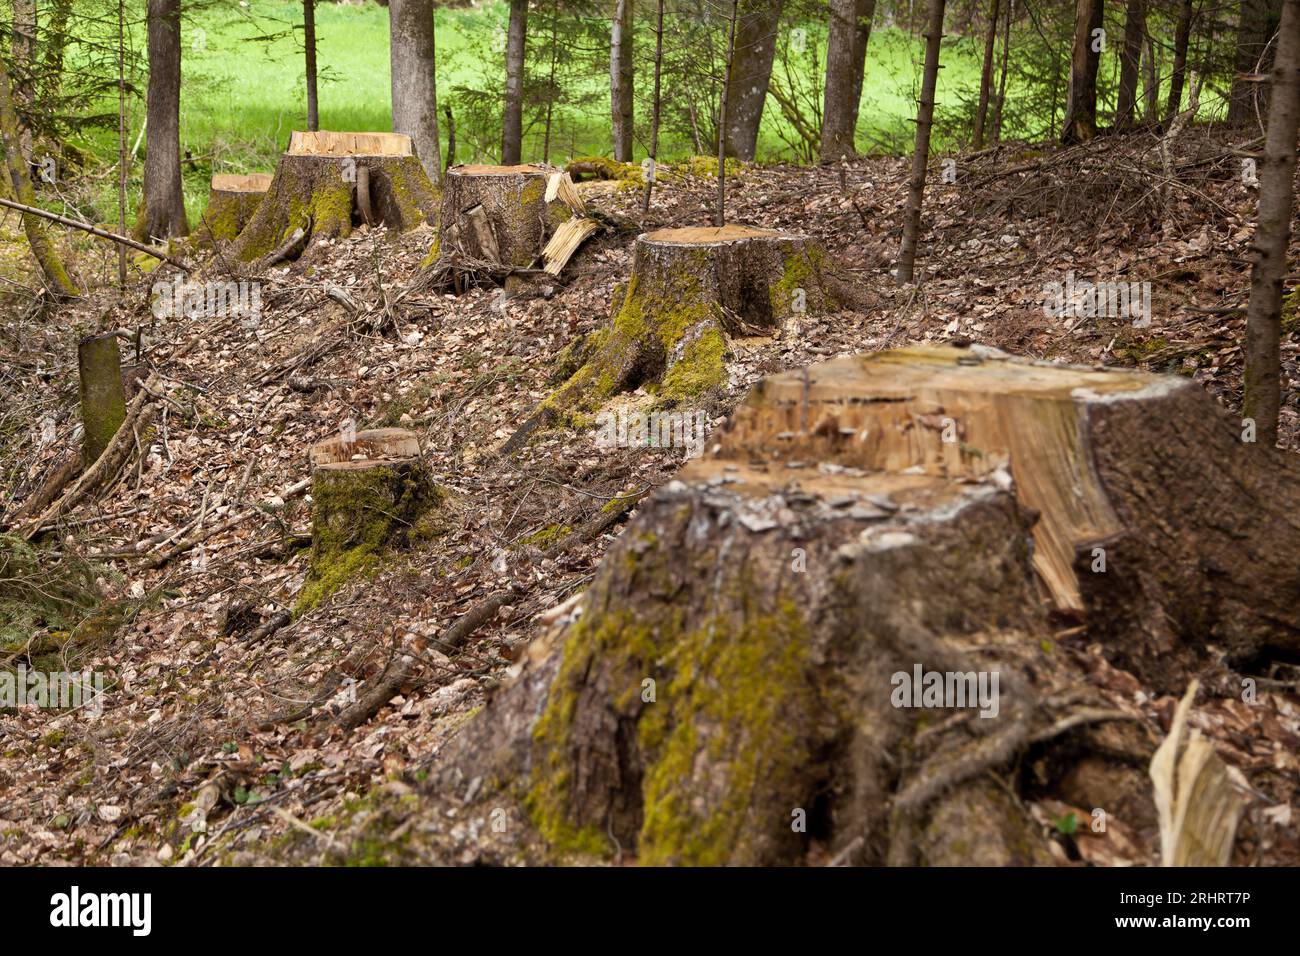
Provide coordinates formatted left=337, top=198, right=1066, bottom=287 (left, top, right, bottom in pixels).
left=428, top=460, right=1060, bottom=865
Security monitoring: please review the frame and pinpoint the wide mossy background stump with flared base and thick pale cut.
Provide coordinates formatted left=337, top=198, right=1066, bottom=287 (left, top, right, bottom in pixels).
left=233, top=133, right=438, bottom=261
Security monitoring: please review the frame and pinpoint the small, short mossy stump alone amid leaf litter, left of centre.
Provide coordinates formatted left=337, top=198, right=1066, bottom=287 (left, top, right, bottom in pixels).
left=298, top=428, right=442, bottom=611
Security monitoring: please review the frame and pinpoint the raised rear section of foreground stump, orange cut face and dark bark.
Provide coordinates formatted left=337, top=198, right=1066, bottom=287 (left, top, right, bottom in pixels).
left=716, top=349, right=1300, bottom=692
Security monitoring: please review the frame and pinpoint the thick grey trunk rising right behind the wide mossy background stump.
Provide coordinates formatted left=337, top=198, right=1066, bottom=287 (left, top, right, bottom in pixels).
left=389, top=0, right=442, bottom=183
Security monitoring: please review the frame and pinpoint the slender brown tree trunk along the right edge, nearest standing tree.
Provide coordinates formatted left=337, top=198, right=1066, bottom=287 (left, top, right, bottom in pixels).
left=1242, top=0, right=1300, bottom=447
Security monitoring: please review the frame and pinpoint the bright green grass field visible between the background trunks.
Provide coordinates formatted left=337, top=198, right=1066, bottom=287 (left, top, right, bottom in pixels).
left=73, top=0, right=979, bottom=219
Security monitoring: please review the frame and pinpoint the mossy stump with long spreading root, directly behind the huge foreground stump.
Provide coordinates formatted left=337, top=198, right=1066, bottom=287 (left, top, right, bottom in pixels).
left=503, top=225, right=849, bottom=454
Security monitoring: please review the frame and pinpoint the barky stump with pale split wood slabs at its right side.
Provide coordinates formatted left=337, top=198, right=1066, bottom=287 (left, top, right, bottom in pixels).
left=426, top=165, right=573, bottom=272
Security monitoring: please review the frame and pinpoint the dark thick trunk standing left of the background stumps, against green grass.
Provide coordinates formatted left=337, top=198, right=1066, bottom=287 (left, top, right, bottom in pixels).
left=135, top=0, right=190, bottom=245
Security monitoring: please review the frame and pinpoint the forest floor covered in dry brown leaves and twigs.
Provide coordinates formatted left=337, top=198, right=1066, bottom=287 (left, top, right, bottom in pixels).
left=0, top=129, right=1300, bottom=865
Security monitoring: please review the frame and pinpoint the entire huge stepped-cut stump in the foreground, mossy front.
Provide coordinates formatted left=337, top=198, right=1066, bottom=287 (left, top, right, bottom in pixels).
left=418, top=349, right=1300, bottom=865
